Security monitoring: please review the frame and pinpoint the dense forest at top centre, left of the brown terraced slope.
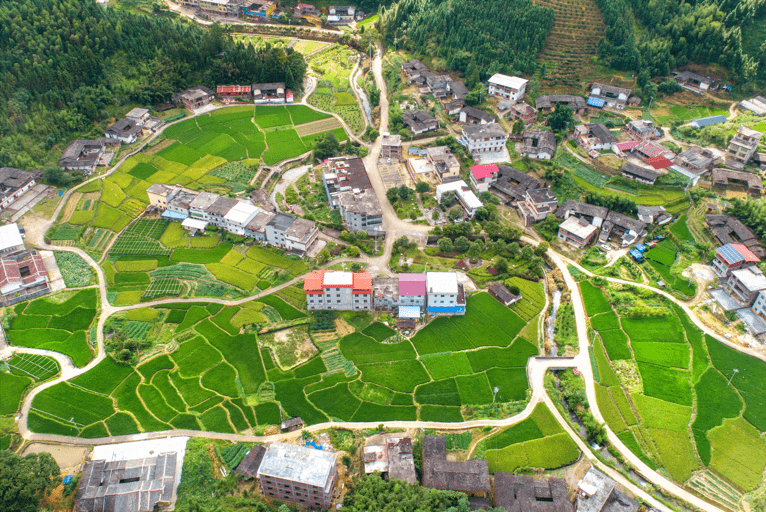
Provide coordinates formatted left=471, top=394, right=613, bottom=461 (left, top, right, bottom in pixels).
left=380, top=0, right=554, bottom=78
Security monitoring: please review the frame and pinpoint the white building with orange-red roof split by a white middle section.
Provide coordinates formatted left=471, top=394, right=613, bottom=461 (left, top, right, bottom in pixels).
left=303, top=270, right=373, bottom=311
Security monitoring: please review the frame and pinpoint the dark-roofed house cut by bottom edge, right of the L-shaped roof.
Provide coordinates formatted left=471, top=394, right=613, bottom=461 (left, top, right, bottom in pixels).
left=494, top=472, right=574, bottom=512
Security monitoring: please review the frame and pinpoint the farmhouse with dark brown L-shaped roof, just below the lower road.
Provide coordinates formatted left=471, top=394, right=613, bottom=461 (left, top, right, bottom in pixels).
left=423, top=436, right=491, bottom=498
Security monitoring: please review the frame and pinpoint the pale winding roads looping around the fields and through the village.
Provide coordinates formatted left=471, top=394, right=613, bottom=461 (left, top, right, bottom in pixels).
left=0, top=41, right=752, bottom=512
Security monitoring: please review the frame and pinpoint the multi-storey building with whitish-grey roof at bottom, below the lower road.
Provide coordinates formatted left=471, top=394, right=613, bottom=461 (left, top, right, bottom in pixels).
left=258, top=443, right=338, bottom=510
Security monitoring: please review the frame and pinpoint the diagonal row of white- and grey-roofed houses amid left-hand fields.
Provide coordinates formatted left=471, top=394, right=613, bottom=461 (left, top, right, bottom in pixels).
left=146, top=183, right=319, bottom=257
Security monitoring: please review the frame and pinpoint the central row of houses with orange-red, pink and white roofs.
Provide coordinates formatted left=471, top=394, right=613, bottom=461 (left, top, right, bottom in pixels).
left=303, top=270, right=466, bottom=320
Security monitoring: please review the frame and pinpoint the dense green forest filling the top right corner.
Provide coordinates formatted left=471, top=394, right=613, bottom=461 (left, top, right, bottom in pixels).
left=596, top=0, right=766, bottom=83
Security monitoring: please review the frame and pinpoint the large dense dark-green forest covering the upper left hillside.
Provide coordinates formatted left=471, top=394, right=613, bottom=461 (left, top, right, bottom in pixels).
left=0, top=0, right=306, bottom=169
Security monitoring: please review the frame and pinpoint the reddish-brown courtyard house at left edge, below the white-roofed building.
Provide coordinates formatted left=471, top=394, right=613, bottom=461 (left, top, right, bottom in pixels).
left=0, top=250, right=50, bottom=306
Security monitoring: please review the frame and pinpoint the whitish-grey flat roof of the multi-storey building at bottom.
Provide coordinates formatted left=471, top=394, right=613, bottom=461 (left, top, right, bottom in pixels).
left=258, top=443, right=337, bottom=491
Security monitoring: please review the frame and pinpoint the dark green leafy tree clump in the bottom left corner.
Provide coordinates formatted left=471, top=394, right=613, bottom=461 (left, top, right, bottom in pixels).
left=0, top=450, right=60, bottom=512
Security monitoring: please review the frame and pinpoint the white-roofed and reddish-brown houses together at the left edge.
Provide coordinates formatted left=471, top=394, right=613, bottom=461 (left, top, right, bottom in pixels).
left=0, top=224, right=51, bottom=306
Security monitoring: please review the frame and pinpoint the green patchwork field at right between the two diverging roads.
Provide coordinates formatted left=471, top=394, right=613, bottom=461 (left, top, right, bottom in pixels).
left=581, top=280, right=766, bottom=491
